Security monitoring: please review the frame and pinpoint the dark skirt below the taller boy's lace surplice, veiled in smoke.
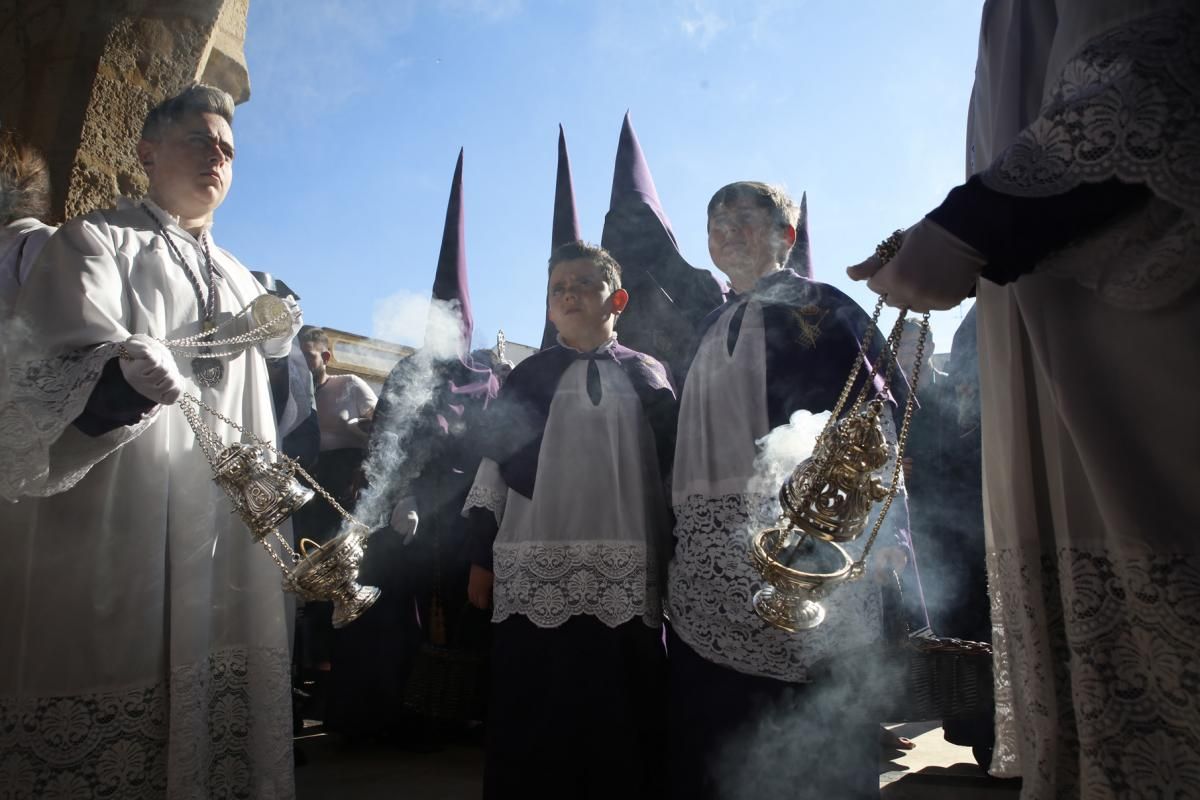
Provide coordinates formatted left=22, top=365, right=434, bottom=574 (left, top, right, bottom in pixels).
left=667, top=627, right=880, bottom=800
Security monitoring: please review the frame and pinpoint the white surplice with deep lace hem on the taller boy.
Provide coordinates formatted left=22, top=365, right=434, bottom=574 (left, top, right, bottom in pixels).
left=667, top=300, right=884, bottom=682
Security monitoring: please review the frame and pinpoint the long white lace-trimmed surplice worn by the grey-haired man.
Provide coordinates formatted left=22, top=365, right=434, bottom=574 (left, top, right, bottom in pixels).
left=0, top=200, right=294, bottom=800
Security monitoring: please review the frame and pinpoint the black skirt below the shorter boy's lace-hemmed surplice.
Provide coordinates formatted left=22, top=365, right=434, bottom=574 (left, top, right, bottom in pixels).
left=484, top=616, right=666, bottom=800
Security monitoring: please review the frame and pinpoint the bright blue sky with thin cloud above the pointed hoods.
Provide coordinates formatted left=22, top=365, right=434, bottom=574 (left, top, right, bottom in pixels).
left=215, top=0, right=982, bottom=350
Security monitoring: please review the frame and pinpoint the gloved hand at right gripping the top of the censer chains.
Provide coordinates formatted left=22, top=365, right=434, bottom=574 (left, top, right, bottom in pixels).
left=846, top=217, right=988, bottom=312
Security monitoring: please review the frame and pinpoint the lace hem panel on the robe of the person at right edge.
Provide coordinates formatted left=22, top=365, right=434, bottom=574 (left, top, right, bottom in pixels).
left=988, top=548, right=1200, bottom=798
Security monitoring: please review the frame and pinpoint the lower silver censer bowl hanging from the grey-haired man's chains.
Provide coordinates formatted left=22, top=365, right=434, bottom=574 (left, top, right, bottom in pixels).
left=283, top=527, right=379, bottom=627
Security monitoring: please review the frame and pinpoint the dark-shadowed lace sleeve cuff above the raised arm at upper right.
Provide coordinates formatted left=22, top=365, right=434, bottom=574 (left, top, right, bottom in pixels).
left=982, top=10, right=1200, bottom=211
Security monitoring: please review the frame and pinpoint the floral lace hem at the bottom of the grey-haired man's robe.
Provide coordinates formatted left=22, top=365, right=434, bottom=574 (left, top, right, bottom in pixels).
left=0, top=649, right=293, bottom=800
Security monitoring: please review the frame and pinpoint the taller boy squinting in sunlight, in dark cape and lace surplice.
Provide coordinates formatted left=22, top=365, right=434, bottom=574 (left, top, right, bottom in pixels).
left=667, top=182, right=902, bottom=800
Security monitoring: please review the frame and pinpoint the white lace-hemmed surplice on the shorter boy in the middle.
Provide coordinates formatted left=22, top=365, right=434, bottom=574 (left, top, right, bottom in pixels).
left=464, top=359, right=668, bottom=627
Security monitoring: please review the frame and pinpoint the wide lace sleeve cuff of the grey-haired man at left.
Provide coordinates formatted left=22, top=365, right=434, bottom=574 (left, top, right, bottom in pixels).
left=0, top=343, right=154, bottom=500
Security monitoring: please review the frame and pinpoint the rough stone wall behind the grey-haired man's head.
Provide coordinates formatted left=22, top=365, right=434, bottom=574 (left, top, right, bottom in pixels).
left=0, top=0, right=250, bottom=221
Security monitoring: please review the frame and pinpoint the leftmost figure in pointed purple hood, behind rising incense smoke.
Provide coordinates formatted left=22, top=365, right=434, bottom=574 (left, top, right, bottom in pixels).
left=330, top=150, right=498, bottom=746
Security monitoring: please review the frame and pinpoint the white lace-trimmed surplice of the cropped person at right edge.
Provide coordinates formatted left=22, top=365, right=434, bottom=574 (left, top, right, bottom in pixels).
left=972, top=0, right=1200, bottom=798
